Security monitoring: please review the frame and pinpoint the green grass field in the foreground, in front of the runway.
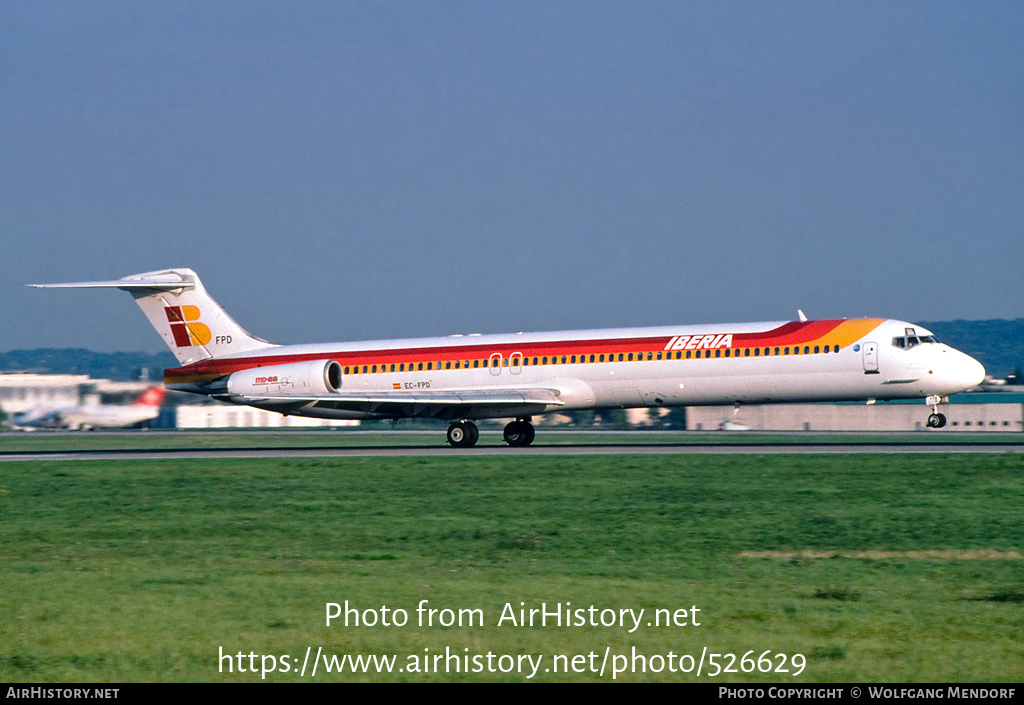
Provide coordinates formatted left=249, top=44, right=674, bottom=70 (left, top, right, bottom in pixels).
left=0, top=454, right=1024, bottom=682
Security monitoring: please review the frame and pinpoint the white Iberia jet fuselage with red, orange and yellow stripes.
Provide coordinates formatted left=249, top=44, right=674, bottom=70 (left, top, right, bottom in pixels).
left=166, top=319, right=984, bottom=418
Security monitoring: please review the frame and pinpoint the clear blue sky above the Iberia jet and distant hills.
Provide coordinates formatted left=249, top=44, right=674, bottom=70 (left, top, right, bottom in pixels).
left=0, top=0, right=1024, bottom=351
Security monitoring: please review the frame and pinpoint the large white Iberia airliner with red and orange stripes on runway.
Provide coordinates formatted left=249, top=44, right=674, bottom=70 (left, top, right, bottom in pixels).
left=30, top=268, right=985, bottom=448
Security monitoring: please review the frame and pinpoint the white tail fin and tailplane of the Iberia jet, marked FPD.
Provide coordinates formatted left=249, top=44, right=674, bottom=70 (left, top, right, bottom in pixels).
left=29, top=268, right=273, bottom=365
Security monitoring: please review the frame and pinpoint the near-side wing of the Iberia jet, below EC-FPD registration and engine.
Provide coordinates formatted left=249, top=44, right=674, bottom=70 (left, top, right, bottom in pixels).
left=218, top=388, right=564, bottom=420
